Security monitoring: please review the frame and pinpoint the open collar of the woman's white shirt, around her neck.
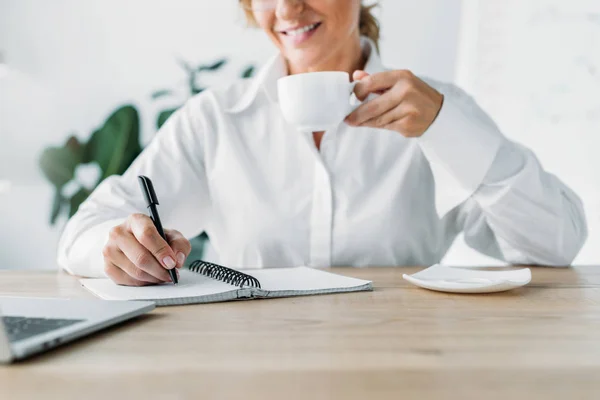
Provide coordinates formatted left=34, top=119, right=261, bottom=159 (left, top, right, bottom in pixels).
left=227, top=36, right=385, bottom=114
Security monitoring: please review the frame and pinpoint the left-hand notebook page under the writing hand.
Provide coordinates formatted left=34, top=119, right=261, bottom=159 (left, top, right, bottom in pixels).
left=81, top=270, right=238, bottom=300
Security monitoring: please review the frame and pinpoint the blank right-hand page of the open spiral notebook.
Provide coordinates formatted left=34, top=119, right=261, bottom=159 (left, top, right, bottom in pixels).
left=243, top=267, right=370, bottom=291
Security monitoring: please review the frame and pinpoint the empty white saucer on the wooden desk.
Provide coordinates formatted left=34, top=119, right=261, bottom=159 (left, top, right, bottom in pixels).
left=402, top=264, right=531, bottom=293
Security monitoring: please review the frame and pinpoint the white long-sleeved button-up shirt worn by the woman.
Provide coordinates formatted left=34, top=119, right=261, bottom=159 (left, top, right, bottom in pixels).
left=58, top=38, right=587, bottom=277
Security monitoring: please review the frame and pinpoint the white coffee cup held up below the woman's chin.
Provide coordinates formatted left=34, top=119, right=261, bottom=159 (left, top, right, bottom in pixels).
left=277, top=71, right=361, bottom=132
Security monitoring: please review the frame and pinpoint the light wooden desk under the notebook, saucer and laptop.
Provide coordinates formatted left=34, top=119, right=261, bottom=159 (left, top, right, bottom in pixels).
left=0, top=267, right=600, bottom=400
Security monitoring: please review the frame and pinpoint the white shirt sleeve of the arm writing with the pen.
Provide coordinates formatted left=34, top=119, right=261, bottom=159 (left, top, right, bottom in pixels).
left=57, top=97, right=211, bottom=277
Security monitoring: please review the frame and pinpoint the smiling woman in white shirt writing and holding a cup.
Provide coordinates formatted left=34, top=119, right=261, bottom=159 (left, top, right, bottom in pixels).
left=59, top=0, right=587, bottom=285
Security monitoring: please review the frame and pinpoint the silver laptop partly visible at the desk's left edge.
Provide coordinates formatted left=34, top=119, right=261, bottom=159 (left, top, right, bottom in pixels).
left=0, top=297, right=154, bottom=363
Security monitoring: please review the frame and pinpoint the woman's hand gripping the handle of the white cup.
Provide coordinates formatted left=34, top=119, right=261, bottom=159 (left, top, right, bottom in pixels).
left=345, top=70, right=444, bottom=137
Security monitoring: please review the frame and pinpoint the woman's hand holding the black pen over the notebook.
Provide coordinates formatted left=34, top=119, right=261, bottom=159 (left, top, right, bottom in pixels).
left=102, top=214, right=191, bottom=286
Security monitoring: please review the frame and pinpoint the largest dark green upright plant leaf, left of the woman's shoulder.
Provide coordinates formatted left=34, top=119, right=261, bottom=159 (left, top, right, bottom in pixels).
left=83, top=105, right=142, bottom=183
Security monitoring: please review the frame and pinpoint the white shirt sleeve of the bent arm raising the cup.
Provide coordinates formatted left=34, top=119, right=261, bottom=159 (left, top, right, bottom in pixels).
left=417, top=86, right=587, bottom=266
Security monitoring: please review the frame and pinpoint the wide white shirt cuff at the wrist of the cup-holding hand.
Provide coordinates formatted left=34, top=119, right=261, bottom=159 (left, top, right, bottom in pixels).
left=417, top=96, right=506, bottom=218
